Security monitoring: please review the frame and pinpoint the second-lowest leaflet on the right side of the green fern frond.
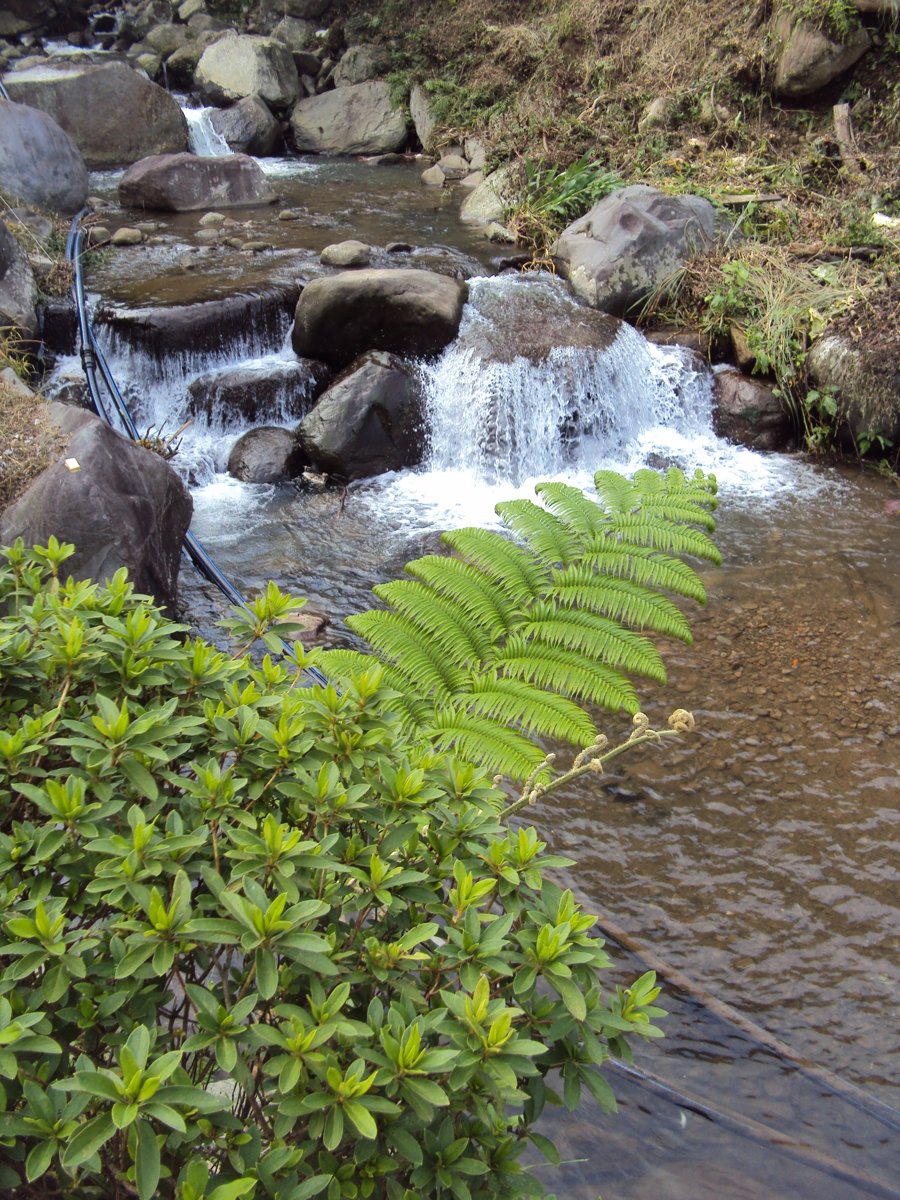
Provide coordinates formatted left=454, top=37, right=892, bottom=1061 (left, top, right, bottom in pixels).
left=460, top=677, right=596, bottom=746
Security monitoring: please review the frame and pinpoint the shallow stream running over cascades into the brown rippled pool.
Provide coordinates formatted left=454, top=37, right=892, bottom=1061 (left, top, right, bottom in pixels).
left=60, top=121, right=900, bottom=1200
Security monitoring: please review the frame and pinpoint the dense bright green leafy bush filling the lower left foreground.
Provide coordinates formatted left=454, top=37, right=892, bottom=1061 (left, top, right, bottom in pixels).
left=0, top=541, right=676, bottom=1200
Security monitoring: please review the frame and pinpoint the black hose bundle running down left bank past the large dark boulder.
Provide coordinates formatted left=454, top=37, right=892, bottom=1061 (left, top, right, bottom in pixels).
left=64, top=211, right=329, bottom=688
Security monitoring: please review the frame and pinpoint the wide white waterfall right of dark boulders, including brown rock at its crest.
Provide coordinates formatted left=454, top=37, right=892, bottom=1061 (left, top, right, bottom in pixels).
left=420, top=276, right=712, bottom=486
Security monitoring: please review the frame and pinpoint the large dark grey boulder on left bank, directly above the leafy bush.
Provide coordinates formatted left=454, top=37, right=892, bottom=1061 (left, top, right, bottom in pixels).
left=0, top=403, right=193, bottom=605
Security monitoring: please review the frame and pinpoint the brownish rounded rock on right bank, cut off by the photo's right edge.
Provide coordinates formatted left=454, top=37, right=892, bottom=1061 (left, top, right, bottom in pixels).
left=806, top=329, right=900, bottom=446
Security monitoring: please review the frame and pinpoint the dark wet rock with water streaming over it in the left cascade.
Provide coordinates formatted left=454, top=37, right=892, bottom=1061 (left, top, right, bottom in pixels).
left=187, top=359, right=331, bottom=425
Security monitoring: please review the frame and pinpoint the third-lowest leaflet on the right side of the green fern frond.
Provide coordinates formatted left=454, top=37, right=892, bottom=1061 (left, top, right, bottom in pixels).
left=497, top=637, right=641, bottom=715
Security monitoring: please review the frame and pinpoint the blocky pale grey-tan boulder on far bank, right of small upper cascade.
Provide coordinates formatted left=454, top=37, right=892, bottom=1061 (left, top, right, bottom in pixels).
left=290, top=80, right=407, bottom=154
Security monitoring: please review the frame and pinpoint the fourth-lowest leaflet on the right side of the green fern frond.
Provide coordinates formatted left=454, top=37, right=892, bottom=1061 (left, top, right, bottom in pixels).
left=522, top=605, right=666, bottom=683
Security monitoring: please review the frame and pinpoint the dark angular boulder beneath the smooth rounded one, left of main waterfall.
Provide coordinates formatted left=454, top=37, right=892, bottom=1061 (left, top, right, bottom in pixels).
left=296, top=352, right=424, bottom=479
